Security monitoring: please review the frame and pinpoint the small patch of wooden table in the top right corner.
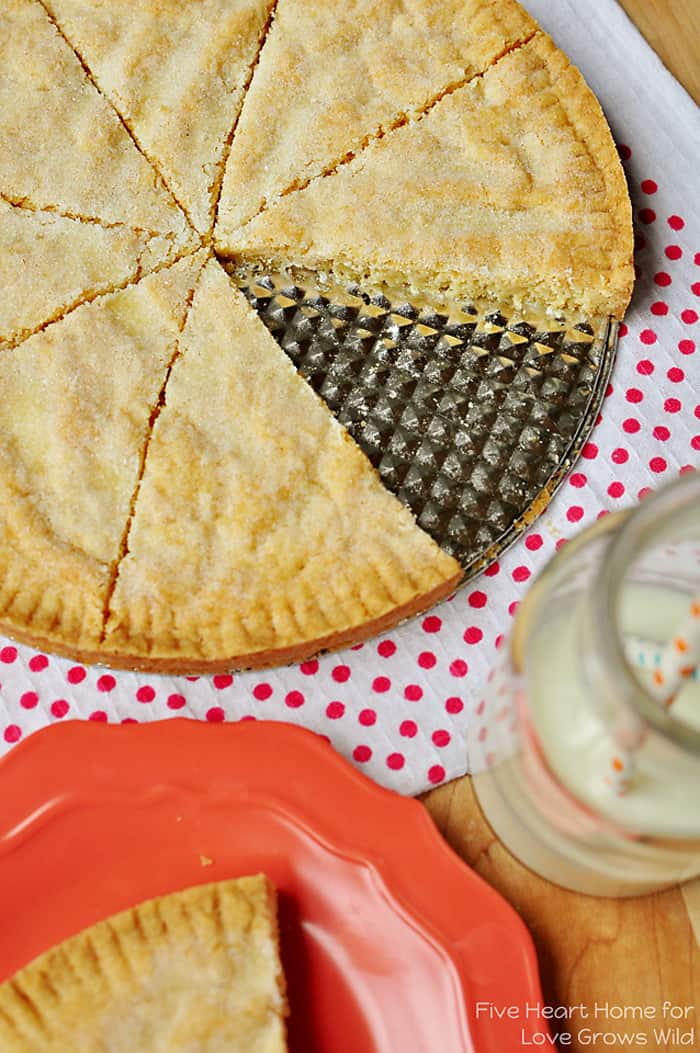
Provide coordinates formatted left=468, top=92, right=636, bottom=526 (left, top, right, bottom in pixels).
left=619, top=0, right=700, bottom=103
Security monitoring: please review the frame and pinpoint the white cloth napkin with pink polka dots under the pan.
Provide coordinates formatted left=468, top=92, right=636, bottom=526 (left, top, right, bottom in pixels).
left=0, top=0, right=700, bottom=794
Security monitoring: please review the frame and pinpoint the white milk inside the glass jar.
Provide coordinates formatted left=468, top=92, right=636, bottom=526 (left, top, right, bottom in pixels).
left=525, top=584, right=700, bottom=837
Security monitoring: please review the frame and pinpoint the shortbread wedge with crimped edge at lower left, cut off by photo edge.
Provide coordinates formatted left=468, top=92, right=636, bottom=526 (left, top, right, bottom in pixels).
left=0, top=251, right=205, bottom=657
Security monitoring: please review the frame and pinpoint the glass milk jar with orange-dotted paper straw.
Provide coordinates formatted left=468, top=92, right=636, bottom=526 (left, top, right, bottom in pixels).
left=469, top=473, right=700, bottom=896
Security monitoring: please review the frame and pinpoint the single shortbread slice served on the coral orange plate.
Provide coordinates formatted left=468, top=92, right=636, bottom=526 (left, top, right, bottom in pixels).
left=0, top=875, right=287, bottom=1053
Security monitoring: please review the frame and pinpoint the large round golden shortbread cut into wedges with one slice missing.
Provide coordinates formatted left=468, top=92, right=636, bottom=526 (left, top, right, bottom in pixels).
left=0, top=0, right=633, bottom=672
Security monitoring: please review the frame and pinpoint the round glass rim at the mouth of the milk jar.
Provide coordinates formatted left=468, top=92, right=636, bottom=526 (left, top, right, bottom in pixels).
left=592, top=472, right=700, bottom=756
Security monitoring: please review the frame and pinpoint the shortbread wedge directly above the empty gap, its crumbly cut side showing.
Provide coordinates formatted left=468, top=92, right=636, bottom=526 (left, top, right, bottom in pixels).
left=225, top=33, right=634, bottom=317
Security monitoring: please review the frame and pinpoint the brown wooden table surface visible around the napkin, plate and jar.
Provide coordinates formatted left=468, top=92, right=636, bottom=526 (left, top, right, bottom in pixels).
left=423, top=0, right=700, bottom=1053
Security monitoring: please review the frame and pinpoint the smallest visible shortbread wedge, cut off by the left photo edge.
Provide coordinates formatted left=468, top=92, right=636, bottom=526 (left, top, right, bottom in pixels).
left=0, top=197, right=188, bottom=351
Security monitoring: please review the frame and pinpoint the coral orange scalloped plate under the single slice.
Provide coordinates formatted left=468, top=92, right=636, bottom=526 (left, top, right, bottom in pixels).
left=0, top=720, right=547, bottom=1053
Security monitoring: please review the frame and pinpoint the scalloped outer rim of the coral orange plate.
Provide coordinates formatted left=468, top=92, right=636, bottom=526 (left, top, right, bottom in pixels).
left=0, top=717, right=546, bottom=1051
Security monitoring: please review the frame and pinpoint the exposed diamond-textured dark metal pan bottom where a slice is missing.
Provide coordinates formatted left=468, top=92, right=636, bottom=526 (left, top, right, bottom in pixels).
left=239, top=267, right=617, bottom=574
